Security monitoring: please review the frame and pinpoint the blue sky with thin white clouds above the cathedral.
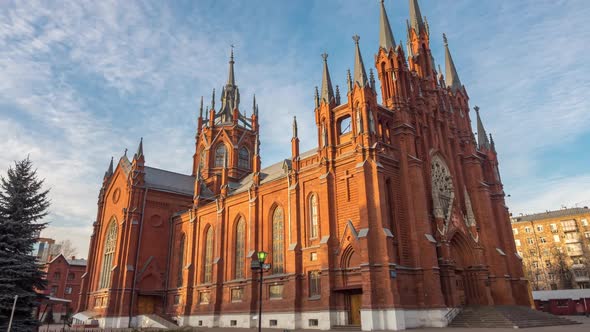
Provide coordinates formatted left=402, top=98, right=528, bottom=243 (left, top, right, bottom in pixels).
left=0, top=0, right=590, bottom=256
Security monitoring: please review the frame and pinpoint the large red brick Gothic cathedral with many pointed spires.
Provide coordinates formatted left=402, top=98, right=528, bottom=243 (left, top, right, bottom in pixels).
left=79, top=0, right=529, bottom=330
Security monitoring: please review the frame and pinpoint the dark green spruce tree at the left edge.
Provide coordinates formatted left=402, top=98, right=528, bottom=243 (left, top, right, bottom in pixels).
left=0, top=157, right=49, bottom=332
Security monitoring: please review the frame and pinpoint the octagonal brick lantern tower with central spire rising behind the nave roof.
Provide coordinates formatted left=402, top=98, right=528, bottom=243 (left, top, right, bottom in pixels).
left=192, top=48, right=260, bottom=203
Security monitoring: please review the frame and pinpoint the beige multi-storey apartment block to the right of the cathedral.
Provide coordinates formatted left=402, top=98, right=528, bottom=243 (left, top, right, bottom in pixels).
left=511, top=207, right=590, bottom=290
